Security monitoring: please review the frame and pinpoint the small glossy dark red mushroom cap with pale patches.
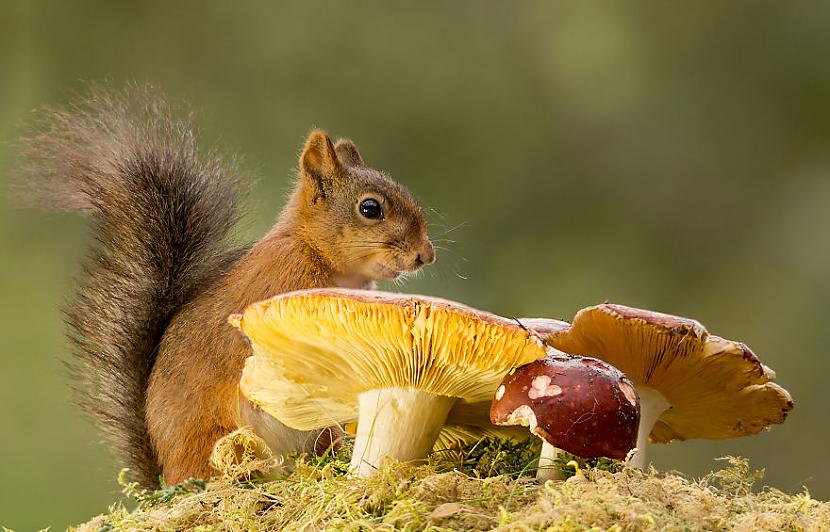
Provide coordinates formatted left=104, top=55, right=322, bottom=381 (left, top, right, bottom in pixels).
left=490, top=356, right=640, bottom=459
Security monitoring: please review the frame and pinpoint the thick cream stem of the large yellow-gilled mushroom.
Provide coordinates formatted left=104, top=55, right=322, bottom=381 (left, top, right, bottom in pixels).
left=350, top=388, right=456, bottom=478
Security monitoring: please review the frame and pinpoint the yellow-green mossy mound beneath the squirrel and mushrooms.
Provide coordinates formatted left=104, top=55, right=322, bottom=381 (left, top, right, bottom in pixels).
left=77, top=435, right=830, bottom=531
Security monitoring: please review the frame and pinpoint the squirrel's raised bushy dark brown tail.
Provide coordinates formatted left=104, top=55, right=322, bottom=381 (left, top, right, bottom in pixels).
left=21, top=88, right=240, bottom=486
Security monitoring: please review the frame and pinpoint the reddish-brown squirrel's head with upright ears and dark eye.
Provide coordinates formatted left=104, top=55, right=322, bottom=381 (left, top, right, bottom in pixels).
left=295, top=130, right=435, bottom=284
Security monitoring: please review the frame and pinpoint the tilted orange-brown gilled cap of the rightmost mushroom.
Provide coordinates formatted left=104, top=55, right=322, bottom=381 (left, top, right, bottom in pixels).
left=522, top=303, right=793, bottom=443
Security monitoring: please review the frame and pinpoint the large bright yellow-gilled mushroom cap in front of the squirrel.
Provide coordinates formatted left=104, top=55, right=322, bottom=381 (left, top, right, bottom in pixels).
left=234, top=289, right=546, bottom=430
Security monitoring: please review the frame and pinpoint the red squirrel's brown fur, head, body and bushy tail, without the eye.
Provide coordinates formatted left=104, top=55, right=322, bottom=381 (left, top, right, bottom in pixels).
left=23, top=89, right=435, bottom=486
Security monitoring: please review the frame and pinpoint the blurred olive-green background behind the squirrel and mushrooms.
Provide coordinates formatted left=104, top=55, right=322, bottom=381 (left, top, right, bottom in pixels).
left=0, top=1, right=830, bottom=530
